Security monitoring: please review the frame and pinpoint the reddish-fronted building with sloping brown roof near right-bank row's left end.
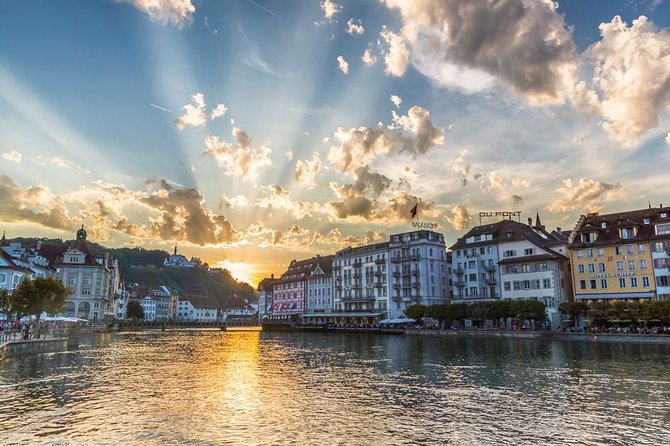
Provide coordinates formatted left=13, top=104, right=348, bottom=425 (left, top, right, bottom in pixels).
left=267, top=256, right=319, bottom=320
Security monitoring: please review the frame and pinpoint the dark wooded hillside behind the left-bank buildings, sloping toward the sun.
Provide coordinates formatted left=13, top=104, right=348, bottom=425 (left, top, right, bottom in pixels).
left=9, top=237, right=256, bottom=308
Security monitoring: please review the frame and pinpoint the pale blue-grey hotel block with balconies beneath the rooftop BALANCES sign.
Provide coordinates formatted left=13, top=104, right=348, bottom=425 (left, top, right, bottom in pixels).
left=389, top=230, right=449, bottom=318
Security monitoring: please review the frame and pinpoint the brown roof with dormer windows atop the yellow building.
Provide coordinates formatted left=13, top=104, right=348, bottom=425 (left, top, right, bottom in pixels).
left=569, top=206, right=670, bottom=248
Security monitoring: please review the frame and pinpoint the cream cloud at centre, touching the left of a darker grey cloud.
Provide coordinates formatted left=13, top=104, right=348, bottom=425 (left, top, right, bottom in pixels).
left=328, top=127, right=393, bottom=172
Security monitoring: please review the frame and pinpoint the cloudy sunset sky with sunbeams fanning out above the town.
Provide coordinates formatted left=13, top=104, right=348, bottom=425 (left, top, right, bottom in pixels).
left=0, top=0, right=670, bottom=284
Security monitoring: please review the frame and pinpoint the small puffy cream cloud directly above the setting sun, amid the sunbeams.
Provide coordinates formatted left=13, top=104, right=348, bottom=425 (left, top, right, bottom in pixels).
left=201, top=127, right=271, bottom=179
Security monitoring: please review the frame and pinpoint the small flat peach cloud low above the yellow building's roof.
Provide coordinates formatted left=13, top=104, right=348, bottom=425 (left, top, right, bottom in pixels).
left=549, top=178, right=623, bottom=212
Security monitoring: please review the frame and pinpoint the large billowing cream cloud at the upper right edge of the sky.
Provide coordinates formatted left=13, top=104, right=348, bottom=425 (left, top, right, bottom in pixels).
left=587, top=16, right=670, bottom=148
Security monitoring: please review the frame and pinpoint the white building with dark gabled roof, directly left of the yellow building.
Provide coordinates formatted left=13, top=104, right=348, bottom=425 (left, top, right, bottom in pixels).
left=502, top=215, right=572, bottom=329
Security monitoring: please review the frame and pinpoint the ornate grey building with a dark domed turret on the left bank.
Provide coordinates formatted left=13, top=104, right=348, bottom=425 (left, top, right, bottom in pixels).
left=39, top=225, right=119, bottom=322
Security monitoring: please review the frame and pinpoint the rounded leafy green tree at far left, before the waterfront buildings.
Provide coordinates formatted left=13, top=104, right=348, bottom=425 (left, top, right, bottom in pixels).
left=10, top=277, right=69, bottom=324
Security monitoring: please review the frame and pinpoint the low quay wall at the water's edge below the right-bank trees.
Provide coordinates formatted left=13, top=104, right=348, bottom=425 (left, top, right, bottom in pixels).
left=405, top=329, right=670, bottom=345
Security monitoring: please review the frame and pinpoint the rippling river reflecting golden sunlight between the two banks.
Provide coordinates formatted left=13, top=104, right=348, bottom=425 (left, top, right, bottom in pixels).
left=0, top=330, right=670, bottom=445
